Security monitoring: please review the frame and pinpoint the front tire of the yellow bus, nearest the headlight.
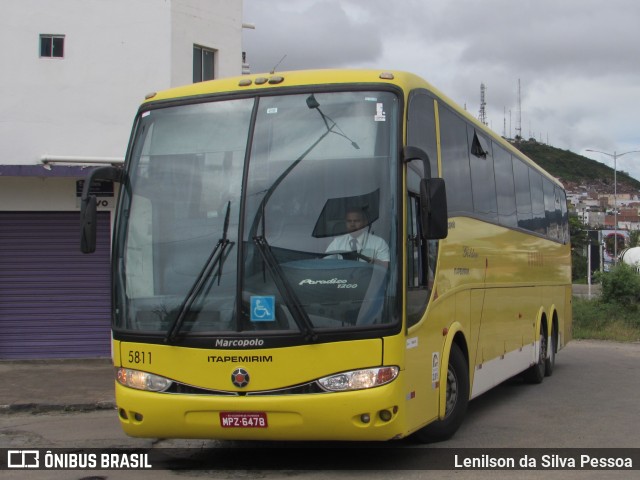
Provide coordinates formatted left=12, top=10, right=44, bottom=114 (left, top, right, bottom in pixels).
left=413, top=343, right=469, bottom=443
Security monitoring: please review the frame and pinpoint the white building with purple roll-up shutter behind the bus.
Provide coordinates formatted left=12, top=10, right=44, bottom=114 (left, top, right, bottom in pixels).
left=0, top=0, right=242, bottom=359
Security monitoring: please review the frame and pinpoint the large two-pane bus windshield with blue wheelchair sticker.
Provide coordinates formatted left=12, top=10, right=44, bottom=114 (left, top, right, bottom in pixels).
left=114, top=91, right=400, bottom=342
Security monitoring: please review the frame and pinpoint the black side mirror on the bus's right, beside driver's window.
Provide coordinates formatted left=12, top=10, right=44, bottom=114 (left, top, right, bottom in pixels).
left=420, top=178, right=449, bottom=240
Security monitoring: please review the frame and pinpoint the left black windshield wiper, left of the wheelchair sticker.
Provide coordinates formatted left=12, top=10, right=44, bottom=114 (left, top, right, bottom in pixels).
left=164, top=202, right=233, bottom=343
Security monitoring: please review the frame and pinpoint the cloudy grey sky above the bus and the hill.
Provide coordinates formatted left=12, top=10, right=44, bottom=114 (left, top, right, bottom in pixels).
left=243, top=0, right=640, bottom=179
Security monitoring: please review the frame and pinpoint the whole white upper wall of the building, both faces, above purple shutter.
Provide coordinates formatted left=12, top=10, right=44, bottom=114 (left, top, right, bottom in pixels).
left=0, top=0, right=242, bottom=169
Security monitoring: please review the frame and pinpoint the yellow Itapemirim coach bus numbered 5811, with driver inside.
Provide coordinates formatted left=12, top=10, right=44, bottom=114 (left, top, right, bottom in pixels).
left=81, top=70, right=571, bottom=441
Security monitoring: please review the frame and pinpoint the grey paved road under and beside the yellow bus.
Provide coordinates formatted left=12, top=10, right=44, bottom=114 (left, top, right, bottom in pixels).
left=0, top=341, right=640, bottom=480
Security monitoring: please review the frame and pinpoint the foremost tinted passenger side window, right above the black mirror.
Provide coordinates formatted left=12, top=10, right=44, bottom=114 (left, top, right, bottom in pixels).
left=440, top=108, right=473, bottom=213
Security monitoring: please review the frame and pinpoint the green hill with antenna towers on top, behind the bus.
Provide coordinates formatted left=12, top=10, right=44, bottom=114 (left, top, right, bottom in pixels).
left=512, top=139, right=640, bottom=193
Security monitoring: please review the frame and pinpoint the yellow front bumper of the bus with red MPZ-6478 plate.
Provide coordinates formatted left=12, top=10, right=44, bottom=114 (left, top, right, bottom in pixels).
left=116, top=379, right=406, bottom=441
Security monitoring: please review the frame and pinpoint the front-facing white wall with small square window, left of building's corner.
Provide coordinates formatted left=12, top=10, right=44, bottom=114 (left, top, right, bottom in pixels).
left=0, top=0, right=165, bottom=164
